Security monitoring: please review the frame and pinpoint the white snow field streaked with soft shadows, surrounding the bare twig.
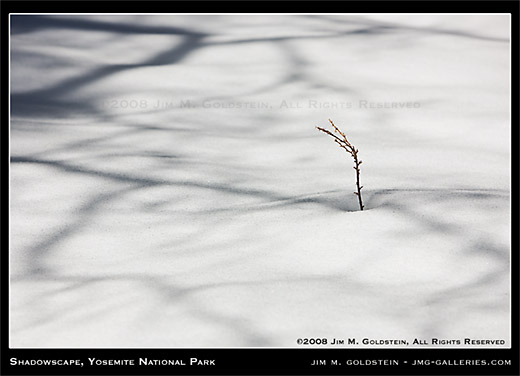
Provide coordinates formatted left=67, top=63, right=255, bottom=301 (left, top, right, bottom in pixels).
left=10, top=15, right=511, bottom=348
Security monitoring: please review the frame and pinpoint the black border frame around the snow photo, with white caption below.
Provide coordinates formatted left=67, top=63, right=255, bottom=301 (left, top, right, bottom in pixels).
left=0, top=1, right=520, bottom=375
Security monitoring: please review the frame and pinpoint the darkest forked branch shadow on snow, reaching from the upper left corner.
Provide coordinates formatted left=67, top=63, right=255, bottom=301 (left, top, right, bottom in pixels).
left=11, top=16, right=362, bottom=117
